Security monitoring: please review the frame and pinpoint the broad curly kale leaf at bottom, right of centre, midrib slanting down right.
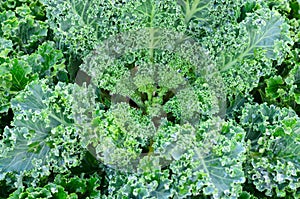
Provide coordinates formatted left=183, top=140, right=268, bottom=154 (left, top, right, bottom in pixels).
left=153, top=119, right=246, bottom=198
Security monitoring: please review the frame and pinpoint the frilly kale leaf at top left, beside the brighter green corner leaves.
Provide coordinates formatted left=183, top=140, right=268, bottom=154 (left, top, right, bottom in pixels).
left=42, top=0, right=109, bottom=57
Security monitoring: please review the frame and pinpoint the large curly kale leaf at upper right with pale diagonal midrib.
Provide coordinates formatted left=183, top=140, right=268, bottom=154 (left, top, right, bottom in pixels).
left=190, top=1, right=294, bottom=97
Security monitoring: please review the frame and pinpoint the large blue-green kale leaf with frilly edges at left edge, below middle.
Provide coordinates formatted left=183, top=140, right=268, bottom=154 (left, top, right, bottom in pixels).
left=0, top=82, right=76, bottom=172
